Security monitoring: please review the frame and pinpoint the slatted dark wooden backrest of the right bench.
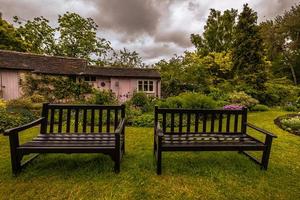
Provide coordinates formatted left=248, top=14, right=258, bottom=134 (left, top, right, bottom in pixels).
left=154, top=107, right=247, bottom=134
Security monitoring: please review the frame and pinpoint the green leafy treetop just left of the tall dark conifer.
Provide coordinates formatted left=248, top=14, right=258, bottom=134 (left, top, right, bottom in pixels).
left=191, top=9, right=237, bottom=55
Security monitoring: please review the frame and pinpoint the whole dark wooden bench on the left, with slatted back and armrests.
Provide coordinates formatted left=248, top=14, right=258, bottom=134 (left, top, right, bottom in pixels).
left=4, top=103, right=125, bottom=174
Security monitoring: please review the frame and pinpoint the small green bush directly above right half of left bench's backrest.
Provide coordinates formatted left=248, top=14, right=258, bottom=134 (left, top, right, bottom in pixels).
left=89, top=90, right=117, bottom=105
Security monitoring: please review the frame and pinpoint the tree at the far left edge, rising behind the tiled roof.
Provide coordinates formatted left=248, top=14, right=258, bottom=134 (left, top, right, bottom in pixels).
left=0, top=13, right=28, bottom=51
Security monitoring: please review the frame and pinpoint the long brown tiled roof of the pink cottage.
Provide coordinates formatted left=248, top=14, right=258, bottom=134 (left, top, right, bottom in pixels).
left=0, top=50, right=160, bottom=78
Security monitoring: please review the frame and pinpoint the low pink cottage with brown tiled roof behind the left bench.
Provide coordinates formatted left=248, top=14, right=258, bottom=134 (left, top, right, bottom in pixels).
left=0, top=50, right=161, bottom=102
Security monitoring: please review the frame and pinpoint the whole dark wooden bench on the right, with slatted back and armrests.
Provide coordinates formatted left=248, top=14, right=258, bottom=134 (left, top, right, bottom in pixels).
left=154, top=107, right=276, bottom=174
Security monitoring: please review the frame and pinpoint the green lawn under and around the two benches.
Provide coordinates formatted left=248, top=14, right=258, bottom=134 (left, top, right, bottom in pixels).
left=0, top=111, right=300, bottom=200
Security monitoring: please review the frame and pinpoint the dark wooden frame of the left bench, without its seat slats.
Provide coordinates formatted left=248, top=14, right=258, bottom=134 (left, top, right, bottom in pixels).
left=4, top=103, right=125, bottom=175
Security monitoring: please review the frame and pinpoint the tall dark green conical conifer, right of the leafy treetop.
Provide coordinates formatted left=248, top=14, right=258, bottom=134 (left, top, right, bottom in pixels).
left=232, top=4, right=267, bottom=89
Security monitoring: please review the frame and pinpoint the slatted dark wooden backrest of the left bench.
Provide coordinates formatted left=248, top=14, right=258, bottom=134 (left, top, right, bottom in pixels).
left=40, top=103, right=125, bottom=134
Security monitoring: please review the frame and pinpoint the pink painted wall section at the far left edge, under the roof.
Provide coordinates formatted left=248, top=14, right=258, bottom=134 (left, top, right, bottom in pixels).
left=0, top=70, right=21, bottom=100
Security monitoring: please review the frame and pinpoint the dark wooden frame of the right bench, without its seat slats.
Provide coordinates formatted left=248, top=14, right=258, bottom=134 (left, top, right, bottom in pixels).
left=153, top=106, right=277, bottom=175
